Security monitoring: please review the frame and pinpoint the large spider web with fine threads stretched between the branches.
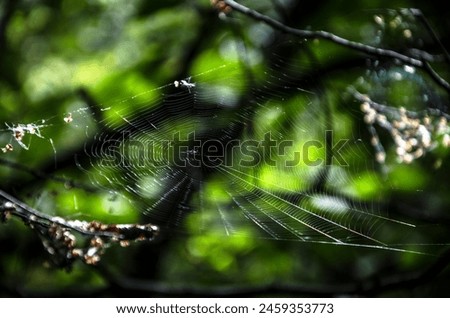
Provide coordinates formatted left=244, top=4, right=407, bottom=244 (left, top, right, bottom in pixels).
left=4, top=8, right=448, bottom=252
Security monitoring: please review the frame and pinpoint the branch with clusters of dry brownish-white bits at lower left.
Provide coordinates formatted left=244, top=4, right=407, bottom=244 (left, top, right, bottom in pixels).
left=0, top=190, right=159, bottom=268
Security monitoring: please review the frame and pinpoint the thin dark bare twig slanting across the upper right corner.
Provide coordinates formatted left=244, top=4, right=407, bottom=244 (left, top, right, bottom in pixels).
left=224, top=0, right=450, bottom=92
